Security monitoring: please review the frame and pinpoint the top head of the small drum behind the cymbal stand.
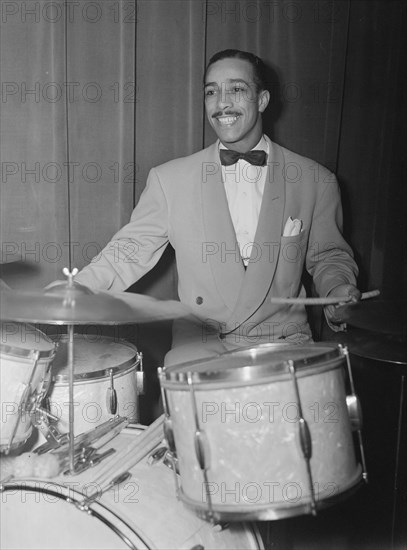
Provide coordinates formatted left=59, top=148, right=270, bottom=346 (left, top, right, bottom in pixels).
left=52, top=334, right=139, bottom=382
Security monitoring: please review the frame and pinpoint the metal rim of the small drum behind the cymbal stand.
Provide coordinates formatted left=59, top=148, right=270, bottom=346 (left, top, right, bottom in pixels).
left=51, top=333, right=140, bottom=384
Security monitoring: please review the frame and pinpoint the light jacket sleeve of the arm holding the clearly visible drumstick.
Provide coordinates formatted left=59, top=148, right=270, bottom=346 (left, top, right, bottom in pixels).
left=306, top=173, right=358, bottom=297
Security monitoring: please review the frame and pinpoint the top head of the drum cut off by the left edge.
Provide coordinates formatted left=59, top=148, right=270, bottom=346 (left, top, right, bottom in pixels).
left=0, top=321, right=55, bottom=358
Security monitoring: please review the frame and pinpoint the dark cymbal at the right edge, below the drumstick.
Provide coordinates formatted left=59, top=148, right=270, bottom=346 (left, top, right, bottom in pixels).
left=330, top=328, right=407, bottom=367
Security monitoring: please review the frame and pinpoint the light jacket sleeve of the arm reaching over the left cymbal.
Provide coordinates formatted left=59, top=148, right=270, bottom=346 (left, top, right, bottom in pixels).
left=75, top=168, right=168, bottom=292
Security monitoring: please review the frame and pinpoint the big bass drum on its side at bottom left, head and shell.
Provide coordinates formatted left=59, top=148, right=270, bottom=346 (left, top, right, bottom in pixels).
left=0, top=429, right=263, bottom=550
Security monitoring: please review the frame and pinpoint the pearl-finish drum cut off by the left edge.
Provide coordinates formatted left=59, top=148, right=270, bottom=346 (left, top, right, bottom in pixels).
left=0, top=322, right=55, bottom=452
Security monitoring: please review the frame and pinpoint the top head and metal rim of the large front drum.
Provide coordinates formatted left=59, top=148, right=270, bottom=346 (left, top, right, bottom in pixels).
left=161, top=343, right=342, bottom=387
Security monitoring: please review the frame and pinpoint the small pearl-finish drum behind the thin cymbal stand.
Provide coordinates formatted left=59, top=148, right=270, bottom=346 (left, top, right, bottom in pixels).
left=47, top=334, right=141, bottom=435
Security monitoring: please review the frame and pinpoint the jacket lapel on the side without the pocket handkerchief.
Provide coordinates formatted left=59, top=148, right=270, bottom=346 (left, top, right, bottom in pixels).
left=201, top=142, right=245, bottom=312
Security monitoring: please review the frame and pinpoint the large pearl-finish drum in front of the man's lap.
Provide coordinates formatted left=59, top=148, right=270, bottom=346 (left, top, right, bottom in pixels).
left=160, top=344, right=362, bottom=521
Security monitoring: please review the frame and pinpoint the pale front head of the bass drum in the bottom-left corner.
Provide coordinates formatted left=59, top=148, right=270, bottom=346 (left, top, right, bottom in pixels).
left=1, top=480, right=139, bottom=550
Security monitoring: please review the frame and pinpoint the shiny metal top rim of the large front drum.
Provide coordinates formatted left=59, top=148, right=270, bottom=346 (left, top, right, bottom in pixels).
left=161, top=342, right=343, bottom=388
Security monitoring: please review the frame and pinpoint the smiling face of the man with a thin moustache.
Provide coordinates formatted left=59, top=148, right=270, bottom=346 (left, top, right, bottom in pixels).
left=204, top=58, right=270, bottom=153
